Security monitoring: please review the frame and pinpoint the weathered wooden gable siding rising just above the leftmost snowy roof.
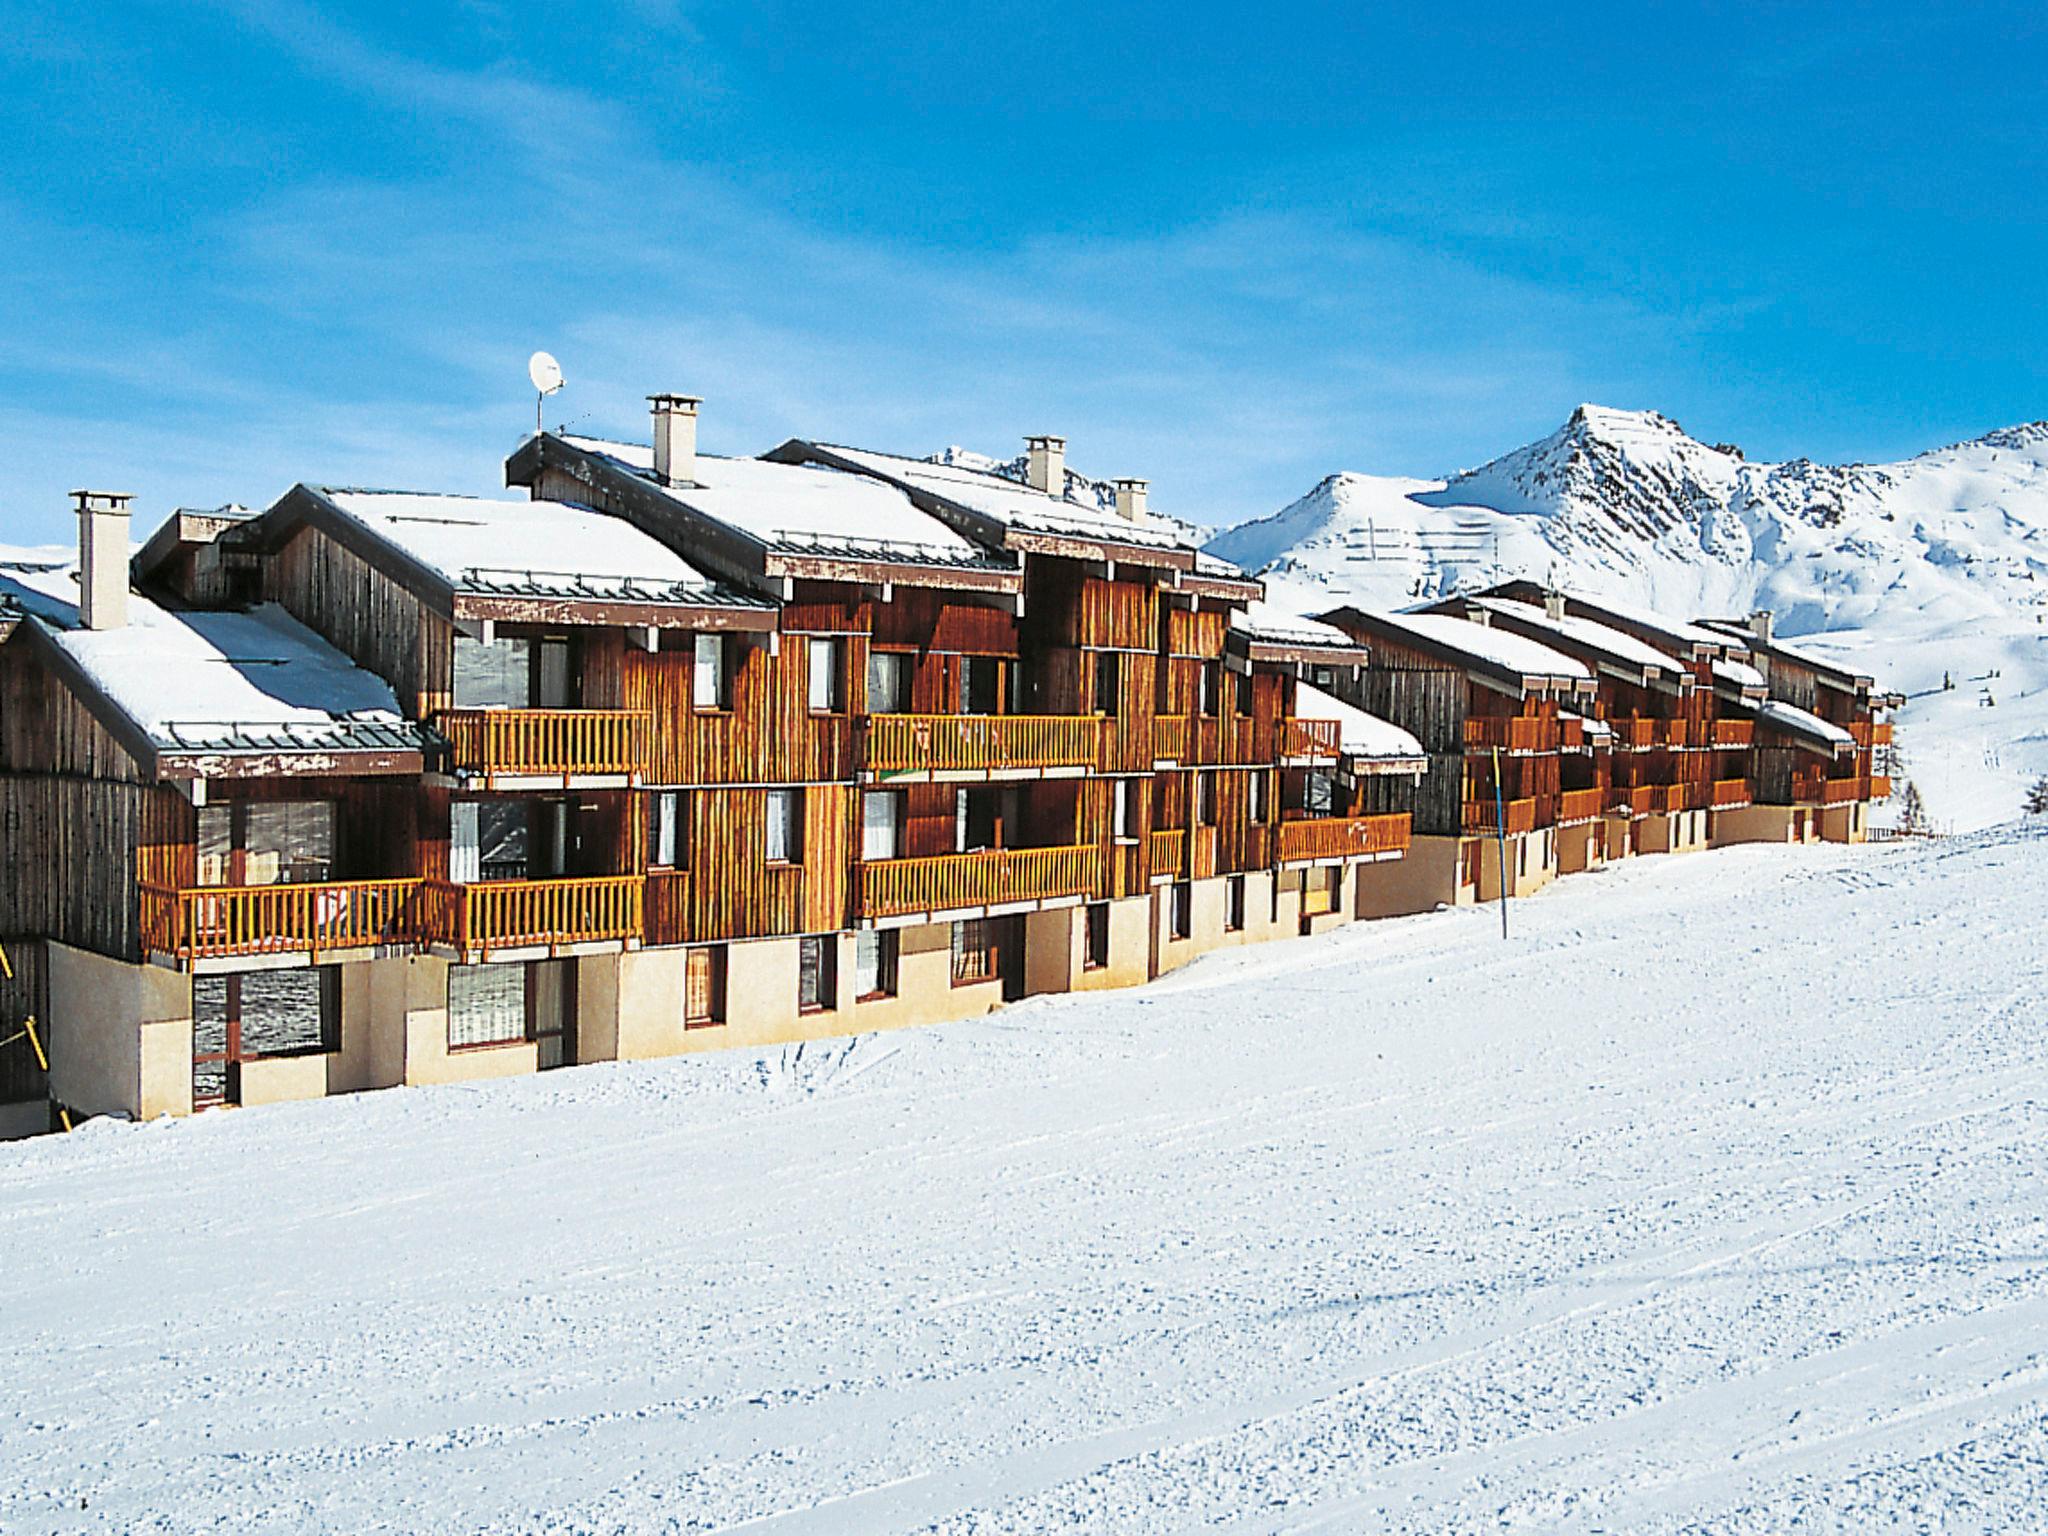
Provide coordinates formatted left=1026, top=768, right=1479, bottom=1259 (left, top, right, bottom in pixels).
left=262, top=528, right=455, bottom=721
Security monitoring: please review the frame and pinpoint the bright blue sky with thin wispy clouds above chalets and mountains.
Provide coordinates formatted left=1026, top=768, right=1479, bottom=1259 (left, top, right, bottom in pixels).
left=0, top=0, right=2048, bottom=543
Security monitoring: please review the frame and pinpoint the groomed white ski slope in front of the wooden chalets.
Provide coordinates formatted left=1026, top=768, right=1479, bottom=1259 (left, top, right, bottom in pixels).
left=0, top=827, right=2048, bottom=1536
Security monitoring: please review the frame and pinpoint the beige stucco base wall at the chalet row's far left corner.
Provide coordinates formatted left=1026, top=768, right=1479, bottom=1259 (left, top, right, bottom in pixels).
left=47, top=942, right=193, bottom=1120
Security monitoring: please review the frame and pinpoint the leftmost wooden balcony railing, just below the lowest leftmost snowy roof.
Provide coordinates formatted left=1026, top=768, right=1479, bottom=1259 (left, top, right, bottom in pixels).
left=139, top=881, right=420, bottom=965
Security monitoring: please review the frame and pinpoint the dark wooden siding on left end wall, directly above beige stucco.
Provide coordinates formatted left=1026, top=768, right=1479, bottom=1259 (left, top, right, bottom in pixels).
left=0, top=774, right=193, bottom=961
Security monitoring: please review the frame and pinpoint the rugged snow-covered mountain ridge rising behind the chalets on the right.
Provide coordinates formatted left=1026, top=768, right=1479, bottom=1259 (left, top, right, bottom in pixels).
left=1210, top=406, right=2048, bottom=633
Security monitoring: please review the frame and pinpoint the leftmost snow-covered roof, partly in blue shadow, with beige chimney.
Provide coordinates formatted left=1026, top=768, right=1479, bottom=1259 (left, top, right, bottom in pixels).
left=0, top=565, right=426, bottom=754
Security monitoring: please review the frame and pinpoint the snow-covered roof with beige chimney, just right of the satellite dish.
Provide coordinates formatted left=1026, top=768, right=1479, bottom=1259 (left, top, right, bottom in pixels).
left=563, top=436, right=987, bottom=565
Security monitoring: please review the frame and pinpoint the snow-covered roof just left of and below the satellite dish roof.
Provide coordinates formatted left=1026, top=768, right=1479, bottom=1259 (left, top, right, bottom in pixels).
left=313, top=485, right=745, bottom=602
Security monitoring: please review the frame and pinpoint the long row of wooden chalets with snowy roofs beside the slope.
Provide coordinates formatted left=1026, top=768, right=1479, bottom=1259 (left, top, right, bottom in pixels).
left=0, top=395, right=1894, bottom=1133
